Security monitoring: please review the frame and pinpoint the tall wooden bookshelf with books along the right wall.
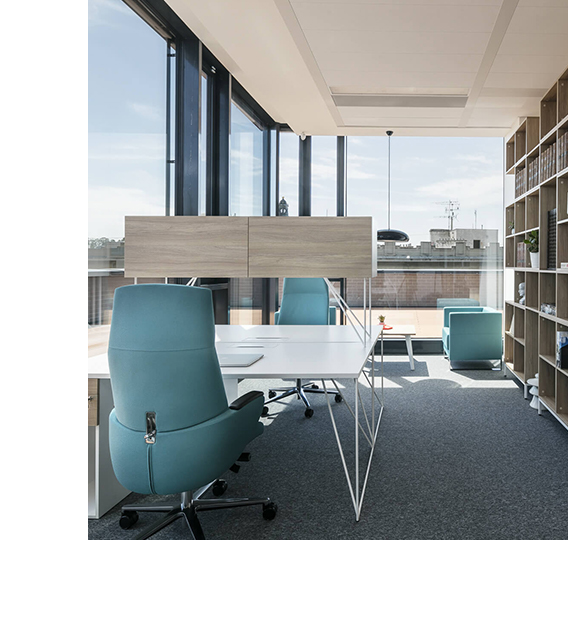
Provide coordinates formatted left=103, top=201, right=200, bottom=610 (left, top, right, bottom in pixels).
left=504, top=68, right=568, bottom=429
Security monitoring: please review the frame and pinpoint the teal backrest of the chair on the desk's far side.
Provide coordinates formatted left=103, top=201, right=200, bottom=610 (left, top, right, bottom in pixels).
left=278, top=278, right=330, bottom=325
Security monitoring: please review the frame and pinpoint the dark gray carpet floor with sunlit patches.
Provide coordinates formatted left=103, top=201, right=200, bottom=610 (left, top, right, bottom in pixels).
left=88, top=356, right=568, bottom=540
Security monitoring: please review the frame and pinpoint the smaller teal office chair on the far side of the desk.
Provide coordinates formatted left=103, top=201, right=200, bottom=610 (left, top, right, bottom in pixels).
left=268, top=278, right=343, bottom=418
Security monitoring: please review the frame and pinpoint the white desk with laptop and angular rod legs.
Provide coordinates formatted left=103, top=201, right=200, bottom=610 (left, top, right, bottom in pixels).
left=89, top=325, right=384, bottom=520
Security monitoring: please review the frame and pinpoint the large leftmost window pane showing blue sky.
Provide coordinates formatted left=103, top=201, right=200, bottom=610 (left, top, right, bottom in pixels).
left=88, top=0, right=174, bottom=338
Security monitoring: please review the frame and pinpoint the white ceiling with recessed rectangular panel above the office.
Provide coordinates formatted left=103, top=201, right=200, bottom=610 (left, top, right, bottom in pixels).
left=166, top=0, right=568, bottom=136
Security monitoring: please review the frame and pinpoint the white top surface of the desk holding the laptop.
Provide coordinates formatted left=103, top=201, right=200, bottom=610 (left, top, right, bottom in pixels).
left=88, top=325, right=381, bottom=379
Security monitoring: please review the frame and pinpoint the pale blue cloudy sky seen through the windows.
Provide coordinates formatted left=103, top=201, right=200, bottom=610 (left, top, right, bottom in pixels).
left=88, top=0, right=503, bottom=245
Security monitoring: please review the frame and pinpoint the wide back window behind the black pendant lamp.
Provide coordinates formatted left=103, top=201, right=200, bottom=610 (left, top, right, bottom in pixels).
left=346, top=135, right=503, bottom=338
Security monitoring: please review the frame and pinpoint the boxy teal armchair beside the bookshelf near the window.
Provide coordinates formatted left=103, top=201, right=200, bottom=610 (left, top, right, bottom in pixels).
left=442, top=306, right=503, bottom=369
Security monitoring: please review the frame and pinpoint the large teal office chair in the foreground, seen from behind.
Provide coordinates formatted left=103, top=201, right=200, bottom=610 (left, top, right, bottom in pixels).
left=108, top=284, right=276, bottom=540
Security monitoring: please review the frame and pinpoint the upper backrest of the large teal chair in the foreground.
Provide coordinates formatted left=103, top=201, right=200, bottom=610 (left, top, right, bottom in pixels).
left=108, top=284, right=228, bottom=432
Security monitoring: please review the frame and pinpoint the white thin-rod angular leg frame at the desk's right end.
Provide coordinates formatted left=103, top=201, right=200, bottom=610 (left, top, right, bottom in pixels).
left=322, top=334, right=384, bottom=521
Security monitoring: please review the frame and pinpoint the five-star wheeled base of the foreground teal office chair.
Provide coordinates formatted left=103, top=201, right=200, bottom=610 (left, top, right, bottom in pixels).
left=120, top=480, right=278, bottom=540
